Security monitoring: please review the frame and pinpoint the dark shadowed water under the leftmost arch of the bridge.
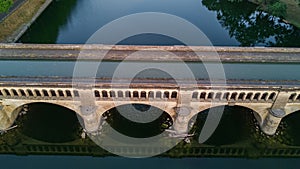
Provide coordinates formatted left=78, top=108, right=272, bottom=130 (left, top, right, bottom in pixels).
left=16, top=103, right=81, bottom=143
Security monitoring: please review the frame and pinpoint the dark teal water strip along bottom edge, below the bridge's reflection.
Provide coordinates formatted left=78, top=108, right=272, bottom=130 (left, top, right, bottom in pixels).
left=0, top=156, right=300, bottom=169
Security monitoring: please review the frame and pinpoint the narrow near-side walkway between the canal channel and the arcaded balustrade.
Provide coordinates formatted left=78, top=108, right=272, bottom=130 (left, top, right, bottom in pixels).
left=0, top=77, right=300, bottom=90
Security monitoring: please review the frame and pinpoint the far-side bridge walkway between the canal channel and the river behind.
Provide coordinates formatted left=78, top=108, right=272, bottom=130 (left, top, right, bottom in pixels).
left=0, top=44, right=300, bottom=63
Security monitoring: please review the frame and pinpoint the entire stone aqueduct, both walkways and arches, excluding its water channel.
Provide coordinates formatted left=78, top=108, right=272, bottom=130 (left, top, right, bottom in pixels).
left=0, top=44, right=300, bottom=135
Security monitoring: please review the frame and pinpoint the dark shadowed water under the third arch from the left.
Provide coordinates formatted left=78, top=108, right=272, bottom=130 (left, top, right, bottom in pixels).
left=190, top=106, right=255, bottom=146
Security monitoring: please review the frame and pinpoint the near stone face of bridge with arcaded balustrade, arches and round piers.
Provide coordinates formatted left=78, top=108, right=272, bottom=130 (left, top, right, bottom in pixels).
left=0, top=77, right=300, bottom=135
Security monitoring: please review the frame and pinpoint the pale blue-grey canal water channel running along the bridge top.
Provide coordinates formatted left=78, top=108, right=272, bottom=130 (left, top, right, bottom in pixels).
left=0, top=61, right=300, bottom=80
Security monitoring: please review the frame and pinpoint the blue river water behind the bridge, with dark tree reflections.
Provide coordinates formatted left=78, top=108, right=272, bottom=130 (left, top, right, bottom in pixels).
left=19, top=0, right=300, bottom=46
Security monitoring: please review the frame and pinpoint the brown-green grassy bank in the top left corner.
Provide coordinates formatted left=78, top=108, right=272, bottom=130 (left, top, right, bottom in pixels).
left=0, top=0, right=45, bottom=42
